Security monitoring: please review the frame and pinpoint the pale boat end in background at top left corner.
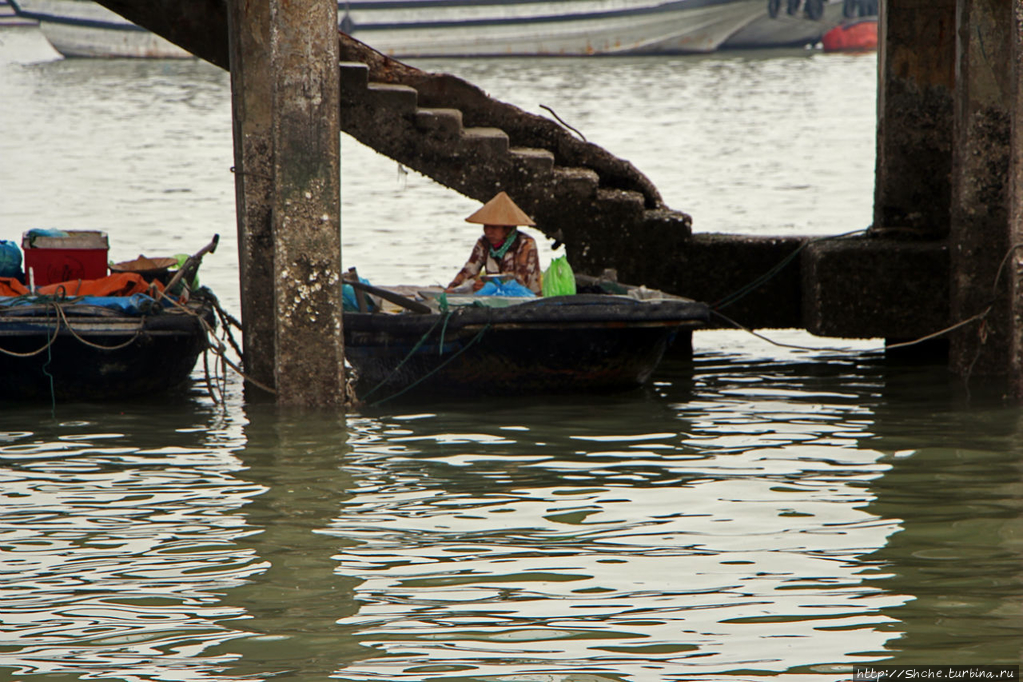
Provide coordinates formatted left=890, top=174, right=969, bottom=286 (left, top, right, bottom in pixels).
left=9, top=0, right=192, bottom=59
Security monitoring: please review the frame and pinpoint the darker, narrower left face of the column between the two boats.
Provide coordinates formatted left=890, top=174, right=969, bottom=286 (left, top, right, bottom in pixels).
left=227, top=0, right=276, bottom=396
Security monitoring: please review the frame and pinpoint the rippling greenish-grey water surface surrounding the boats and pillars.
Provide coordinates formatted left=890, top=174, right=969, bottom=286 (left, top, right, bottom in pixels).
left=0, top=30, right=1023, bottom=682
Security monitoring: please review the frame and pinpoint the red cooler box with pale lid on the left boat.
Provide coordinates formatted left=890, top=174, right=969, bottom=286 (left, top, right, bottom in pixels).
left=21, top=230, right=109, bottom=286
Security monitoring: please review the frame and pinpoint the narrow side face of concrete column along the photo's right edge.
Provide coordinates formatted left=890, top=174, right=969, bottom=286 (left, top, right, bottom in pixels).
left=1006, top=0, right=1023, bottom=398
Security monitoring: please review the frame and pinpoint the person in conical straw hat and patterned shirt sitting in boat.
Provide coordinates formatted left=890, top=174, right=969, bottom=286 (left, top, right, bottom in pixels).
left=447, top=192, right=540, bottom=294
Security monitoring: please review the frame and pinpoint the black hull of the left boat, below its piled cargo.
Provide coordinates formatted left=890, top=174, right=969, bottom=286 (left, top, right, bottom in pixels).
left=0, top=289, right=216, bottom=402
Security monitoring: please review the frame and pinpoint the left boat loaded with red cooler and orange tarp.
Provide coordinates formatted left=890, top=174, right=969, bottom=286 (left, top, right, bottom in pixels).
left=0, top=237, right=220, bottom=402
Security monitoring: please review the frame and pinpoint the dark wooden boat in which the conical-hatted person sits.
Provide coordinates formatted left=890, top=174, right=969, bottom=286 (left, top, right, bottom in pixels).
left=344, top=280, right=710, bottom=404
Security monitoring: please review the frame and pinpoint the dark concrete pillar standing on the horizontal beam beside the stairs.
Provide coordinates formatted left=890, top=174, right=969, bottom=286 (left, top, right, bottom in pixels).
left=874, top=0, right=955, bottom=237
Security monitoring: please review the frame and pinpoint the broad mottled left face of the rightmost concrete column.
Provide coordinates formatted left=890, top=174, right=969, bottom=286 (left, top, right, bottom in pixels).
left=949, top=0, right=1019, bottom=376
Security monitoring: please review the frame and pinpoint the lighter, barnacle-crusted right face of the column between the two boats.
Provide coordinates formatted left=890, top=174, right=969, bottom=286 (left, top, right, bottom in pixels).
left=267, top=0, right=345, bottom=406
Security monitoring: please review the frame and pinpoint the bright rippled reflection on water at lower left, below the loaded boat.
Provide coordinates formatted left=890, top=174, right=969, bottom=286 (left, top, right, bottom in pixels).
left=0, top=406, right=259, bottom=679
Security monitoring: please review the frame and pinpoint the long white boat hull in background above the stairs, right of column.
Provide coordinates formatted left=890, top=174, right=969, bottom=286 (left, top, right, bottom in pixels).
left=339, top=0, right=764, bottom=57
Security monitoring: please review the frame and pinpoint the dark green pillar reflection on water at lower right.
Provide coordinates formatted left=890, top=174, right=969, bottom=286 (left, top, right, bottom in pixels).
left=864, top=393, right=1023, bottom=665
